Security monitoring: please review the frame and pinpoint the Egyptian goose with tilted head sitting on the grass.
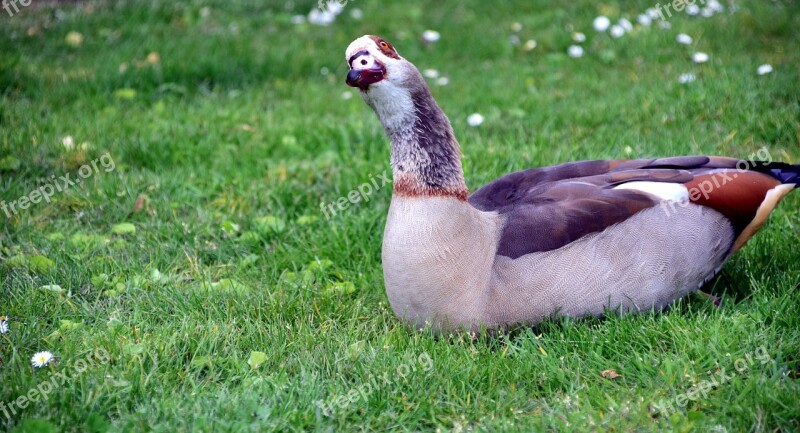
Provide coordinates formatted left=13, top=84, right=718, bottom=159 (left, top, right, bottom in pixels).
left=345, top=35, right=800, bottom=331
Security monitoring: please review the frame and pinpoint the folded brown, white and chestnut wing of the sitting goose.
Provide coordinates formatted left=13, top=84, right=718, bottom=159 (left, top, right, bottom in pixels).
left=469, top=156, right=800, bottom=258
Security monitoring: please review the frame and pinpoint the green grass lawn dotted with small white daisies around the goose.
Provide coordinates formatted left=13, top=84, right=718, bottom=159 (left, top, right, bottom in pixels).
left=0, top=0, right=800, bottom=432
